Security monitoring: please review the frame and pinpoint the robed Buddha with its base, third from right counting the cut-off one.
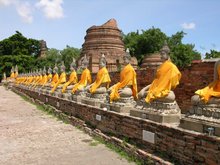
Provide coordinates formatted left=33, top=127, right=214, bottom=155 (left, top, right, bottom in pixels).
left=105, top=49, right=137, bottom=113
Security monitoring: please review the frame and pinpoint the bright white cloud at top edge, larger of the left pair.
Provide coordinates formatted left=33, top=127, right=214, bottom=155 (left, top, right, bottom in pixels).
left=36, top=0, right=64, bottom=19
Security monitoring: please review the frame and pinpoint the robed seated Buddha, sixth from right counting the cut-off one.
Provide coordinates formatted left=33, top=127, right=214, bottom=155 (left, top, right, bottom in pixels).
left=62, top=58, right=78, bottom=93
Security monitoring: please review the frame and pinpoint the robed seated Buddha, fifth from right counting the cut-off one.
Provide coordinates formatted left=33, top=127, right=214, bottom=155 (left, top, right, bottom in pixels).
left=72, top=55, right=92, bottom=94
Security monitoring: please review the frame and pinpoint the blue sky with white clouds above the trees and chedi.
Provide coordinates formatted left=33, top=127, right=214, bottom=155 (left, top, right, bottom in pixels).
left=0, top=0, right=220, bottom=54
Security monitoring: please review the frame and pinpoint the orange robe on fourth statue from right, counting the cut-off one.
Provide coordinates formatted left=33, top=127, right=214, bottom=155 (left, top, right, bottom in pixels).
left=89, top=67, right=111, bottom=93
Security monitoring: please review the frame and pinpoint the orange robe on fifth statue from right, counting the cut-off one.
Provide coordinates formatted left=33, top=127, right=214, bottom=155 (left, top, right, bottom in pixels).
left=72, top=68, right=92, bottom=93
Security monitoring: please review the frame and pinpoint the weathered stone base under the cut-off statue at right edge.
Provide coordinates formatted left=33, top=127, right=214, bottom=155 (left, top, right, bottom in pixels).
left=180, top=104, right=220, bottom=136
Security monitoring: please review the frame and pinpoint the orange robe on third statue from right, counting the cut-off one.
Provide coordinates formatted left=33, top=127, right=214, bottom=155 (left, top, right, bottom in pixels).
left=110, top=64, right=137, bottom=102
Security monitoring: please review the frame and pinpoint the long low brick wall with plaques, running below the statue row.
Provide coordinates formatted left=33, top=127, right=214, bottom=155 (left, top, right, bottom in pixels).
left=17, top=87, right=220, bottom=165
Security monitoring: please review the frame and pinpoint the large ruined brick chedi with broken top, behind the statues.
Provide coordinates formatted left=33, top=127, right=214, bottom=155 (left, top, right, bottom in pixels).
left=78, top=19, right=137, bottom=73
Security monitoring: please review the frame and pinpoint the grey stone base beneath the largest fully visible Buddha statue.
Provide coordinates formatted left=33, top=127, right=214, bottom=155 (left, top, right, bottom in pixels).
left=130, top=101, right=181, bottom=124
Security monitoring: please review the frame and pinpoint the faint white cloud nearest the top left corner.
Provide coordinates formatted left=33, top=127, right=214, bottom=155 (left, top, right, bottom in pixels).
left=16, top=2, right=33, bottom=23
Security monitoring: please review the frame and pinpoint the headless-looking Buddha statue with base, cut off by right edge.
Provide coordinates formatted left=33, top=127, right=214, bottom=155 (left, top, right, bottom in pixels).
left=180, top=60, right=220, bottom=136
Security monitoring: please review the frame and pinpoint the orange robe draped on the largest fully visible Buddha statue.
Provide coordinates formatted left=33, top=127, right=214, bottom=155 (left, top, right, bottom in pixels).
left=145, top=60, right=181, bottom=103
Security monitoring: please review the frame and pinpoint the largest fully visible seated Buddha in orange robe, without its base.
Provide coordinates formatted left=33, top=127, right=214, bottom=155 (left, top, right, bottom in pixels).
left=138, top=42, right=181, bottom=103
